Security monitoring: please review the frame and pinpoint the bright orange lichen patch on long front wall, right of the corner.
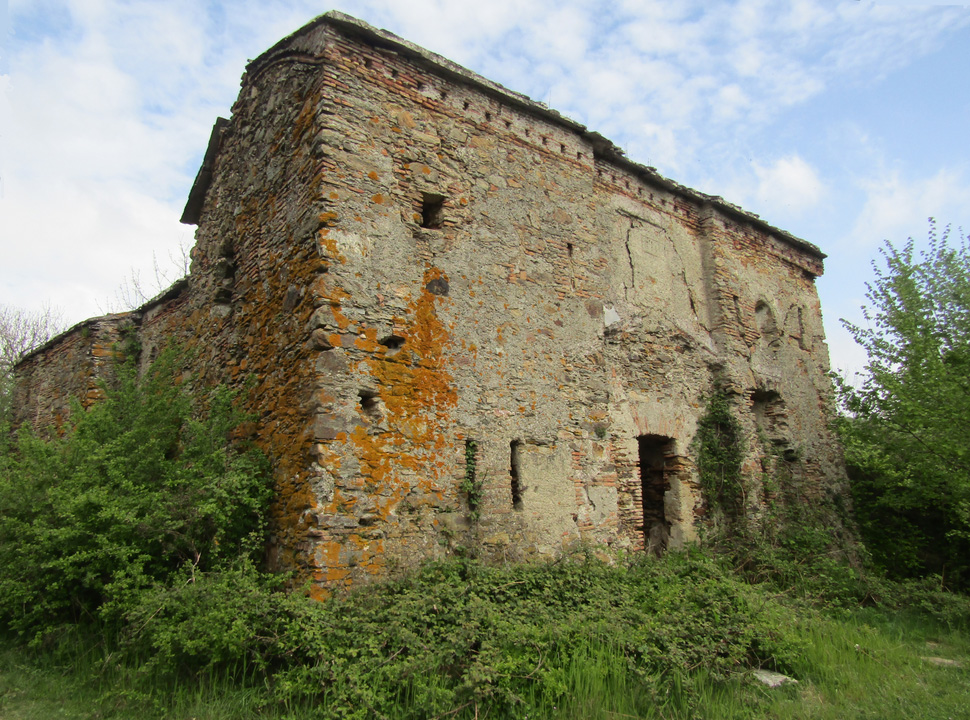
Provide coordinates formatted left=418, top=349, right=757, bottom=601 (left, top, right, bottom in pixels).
left=306, top=267, right=458, bottom=586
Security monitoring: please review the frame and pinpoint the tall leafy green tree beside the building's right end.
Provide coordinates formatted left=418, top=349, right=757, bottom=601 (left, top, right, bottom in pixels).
left=840, top=220, right=970, bottom=588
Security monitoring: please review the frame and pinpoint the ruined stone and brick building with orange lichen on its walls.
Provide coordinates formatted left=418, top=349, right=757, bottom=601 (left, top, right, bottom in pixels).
left=17, top=13, right=843, bottom=588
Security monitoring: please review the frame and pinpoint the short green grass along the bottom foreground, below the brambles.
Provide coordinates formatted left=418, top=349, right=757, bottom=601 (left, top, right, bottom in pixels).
left=0, top=611, right=970, bottom=720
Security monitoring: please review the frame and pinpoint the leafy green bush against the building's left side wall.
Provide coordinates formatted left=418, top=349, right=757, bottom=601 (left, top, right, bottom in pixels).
left=0, top=350, right=270, bottom=636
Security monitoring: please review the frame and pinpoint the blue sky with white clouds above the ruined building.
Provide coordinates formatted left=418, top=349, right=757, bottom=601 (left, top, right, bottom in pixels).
left=0, top=0, right=970, bottom=376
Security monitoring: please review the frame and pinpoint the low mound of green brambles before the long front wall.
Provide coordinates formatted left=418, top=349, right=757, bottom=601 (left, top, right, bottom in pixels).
left=268, top=552, right=800, bottom=718
